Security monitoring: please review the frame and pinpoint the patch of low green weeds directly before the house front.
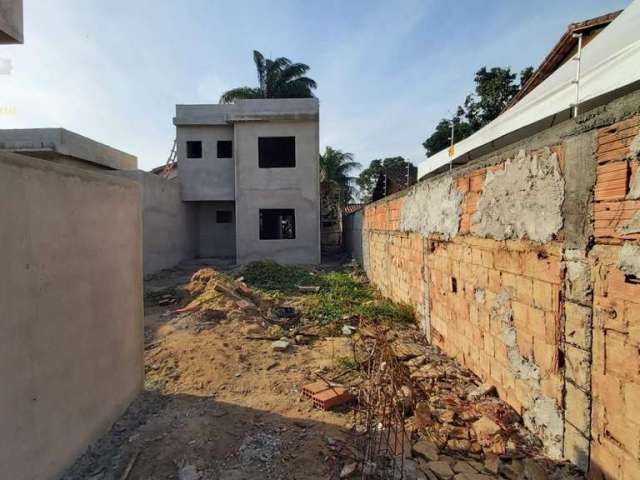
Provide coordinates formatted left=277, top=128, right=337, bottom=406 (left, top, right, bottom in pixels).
left=242, top=261, right=318, bottom=293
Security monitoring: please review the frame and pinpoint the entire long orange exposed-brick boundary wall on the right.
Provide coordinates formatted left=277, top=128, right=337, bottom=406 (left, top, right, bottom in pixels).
left=363, top=111, right=640, bottom=480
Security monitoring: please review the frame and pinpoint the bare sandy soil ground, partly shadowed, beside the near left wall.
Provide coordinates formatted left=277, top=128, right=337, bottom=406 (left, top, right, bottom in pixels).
left=63, top=262, right=584, bottom=480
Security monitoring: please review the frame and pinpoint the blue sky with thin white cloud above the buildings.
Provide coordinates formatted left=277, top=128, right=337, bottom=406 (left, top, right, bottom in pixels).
left=0, top=0, right=629, bottom=170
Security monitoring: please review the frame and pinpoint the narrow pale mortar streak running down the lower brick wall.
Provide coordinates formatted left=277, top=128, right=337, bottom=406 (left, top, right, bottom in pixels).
left=489, top=289, right=564, bottom=459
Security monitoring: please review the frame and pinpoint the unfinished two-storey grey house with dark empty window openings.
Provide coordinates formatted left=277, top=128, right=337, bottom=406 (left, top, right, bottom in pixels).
left=174, top=98, right=320, bottom=264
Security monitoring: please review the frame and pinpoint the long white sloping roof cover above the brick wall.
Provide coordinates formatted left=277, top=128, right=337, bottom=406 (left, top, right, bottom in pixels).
left=418, top=0, right=640, bottom=178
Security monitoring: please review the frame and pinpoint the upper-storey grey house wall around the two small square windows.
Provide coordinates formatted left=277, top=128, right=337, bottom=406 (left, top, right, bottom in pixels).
left=176, top=125, right=235, bottom=201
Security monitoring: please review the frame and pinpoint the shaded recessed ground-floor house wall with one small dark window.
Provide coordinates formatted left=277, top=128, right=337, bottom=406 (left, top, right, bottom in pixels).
left=199, top=202, right=236, bottom=258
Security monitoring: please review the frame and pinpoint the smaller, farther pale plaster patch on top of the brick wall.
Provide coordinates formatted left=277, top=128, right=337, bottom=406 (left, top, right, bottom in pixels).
left=400, top=176, right=463, bottom=238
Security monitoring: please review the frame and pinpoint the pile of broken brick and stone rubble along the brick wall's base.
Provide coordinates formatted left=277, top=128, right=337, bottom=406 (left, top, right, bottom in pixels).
left=343, top=325, right=583, bottom=480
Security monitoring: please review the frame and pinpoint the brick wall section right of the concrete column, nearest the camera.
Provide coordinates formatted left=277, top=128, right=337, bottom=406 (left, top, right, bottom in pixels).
left=590, top=117, right=640, bottom=480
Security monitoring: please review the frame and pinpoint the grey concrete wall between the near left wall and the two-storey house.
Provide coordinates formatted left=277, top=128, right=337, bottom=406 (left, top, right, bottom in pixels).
left=113, top=170, right=198, bottom=275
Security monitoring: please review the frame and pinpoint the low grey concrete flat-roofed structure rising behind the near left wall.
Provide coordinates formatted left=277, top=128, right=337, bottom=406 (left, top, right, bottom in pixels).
left=0, top=128, right=138, bottom=170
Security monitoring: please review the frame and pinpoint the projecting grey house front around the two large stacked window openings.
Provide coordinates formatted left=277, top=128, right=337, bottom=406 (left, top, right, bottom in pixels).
left=234, top=120, right=320, bottom=264
